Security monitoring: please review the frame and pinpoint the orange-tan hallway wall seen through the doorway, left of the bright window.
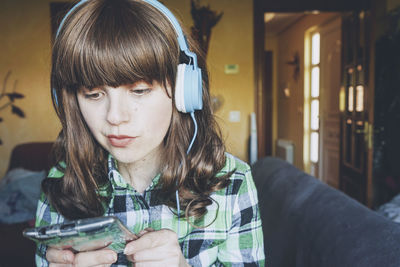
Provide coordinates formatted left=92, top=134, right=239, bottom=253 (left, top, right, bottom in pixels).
left=277, top=13, right=335, bottom=169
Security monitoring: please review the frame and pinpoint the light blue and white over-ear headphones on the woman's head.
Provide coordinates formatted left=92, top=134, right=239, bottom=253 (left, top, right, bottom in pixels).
left=52, top=0, right=203, bottom=113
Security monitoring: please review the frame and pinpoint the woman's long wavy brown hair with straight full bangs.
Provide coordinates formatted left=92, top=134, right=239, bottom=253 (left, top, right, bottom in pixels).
left=42, top=0, right=230, bottom=222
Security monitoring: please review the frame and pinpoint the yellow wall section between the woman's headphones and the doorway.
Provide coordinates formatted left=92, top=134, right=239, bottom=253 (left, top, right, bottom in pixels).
left=164, top=0, right=254, bottom=160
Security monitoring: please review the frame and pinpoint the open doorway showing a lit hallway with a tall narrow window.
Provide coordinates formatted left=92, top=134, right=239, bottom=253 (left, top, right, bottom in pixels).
left=265, top=12, right=341, bottom=188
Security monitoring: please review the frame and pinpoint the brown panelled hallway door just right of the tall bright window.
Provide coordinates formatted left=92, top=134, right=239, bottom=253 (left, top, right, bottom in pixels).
left=318, top=16, right=342, bottom=188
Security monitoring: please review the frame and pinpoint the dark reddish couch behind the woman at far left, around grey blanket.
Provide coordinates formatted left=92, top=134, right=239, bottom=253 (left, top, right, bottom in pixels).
left=0, top=142, right=53, bottom=267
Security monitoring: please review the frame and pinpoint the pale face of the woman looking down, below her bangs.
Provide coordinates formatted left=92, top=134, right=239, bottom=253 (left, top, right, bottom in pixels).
left=77, top=82, right=172, bottom=164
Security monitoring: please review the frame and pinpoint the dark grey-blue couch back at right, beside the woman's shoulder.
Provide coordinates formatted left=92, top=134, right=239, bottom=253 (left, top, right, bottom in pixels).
left=252, top=157, right=400, bottom=267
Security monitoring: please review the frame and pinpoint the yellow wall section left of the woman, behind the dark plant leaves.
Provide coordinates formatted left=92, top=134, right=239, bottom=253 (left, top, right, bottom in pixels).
left=0, top=0, right=59, bottom=178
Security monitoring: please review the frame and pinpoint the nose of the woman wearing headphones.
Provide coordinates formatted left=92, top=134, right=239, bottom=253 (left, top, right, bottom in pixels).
left=107, top=94, right=130, bottom=125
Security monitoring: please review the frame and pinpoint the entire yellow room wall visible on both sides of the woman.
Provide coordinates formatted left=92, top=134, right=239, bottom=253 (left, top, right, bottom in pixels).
left=0, top=0, right=254, bottom=177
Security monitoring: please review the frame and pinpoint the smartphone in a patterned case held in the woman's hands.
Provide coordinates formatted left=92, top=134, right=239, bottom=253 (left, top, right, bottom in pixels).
left=23, top=216, right=137, bottom=253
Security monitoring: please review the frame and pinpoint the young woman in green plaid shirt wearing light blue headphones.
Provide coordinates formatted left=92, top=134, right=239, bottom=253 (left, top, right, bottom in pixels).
left=36, top=0, right=264, bottom=266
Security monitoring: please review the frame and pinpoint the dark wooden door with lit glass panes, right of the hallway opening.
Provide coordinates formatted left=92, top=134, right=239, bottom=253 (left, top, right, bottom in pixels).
left=340, top=11, right=371, bottom=204
